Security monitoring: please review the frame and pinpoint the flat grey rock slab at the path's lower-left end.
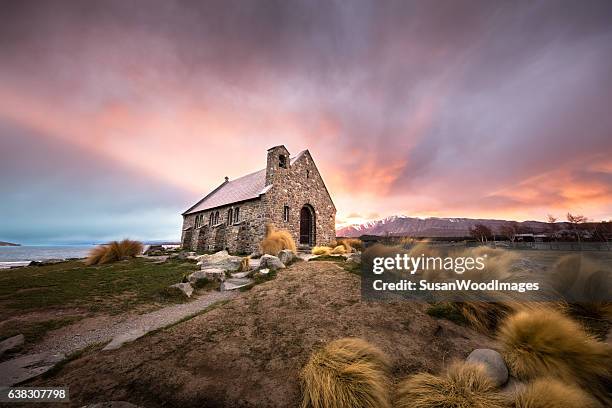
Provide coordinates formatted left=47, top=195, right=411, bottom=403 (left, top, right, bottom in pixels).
left=0, top=353, right=65, bottom=387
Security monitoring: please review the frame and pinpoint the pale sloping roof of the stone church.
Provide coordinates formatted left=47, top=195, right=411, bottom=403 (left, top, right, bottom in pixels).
left=183, top=150, right=306, bottom=215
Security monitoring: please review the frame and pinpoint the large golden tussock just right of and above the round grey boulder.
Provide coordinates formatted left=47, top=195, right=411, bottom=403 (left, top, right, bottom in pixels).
left=499, top=308, right=612, bottom=399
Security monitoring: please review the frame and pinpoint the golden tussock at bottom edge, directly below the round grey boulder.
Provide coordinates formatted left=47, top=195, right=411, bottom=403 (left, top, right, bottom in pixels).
left=395, top=362, right=507, bottom=408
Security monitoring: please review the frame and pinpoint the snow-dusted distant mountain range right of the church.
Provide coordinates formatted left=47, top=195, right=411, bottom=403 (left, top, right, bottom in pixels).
left=336, top=215, right=568, bottom=238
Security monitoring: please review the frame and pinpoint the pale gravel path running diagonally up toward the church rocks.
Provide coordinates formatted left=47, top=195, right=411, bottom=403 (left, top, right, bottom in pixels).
left=31, top=291, right=238, bottom=355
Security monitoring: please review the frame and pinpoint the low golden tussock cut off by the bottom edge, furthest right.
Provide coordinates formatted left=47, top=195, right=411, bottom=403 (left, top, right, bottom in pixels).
left=513, top=378, right=599, bottom=408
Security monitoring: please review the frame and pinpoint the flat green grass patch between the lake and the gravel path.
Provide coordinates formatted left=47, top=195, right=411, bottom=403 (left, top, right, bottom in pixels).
left=0, top=258, right=195, bottom=318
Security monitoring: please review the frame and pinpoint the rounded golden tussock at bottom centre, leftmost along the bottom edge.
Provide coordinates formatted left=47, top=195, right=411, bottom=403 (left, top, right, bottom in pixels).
left=300, top=338, right=391, bottom=408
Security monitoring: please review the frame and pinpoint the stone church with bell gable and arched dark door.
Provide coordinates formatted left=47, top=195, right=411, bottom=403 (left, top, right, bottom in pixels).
left=181, top=146, right=336, bottom=254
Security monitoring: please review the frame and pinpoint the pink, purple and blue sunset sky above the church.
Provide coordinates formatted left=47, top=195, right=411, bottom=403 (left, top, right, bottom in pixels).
left=0, top=0, right=612, bottom=244
